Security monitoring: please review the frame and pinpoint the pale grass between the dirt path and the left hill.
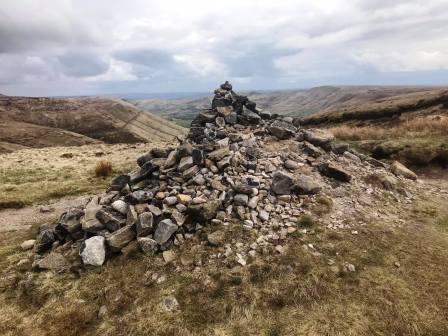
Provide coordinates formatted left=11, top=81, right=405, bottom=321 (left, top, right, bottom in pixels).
left=0, top=145, right=150, bottom=209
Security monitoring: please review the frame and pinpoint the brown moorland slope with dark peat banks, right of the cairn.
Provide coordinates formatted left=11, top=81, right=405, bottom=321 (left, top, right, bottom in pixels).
left=297, top=88, right=448, bottom=168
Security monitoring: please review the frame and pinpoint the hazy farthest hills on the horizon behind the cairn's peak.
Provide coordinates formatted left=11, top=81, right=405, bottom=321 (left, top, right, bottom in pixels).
left=132, top=86, right=442, bottom=124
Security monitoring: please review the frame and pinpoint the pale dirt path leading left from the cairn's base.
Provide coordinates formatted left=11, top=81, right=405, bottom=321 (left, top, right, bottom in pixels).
left=0, top=195, right=90, bottom=232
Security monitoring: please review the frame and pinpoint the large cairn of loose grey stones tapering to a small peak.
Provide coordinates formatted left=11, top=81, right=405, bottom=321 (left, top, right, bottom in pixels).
left=34, top=82, right=404, bottom=268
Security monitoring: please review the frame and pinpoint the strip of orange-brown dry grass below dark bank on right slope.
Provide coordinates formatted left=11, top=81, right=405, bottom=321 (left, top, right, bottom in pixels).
left=330, top=116, right=448, bottom=141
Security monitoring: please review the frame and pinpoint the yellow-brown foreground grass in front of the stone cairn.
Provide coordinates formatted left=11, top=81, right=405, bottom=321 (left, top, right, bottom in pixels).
left=0, top=196, right=448, bottom=336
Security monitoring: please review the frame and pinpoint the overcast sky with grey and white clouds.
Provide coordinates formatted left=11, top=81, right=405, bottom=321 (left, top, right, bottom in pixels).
left=0, top=0, right=448, bottom=96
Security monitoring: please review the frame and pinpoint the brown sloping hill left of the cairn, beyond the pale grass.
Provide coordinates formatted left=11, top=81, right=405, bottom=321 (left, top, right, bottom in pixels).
left=0, top=97, right=185, bottom=152
